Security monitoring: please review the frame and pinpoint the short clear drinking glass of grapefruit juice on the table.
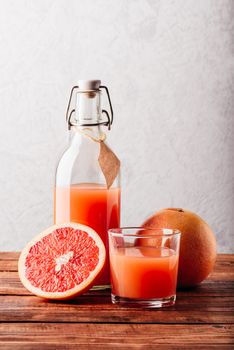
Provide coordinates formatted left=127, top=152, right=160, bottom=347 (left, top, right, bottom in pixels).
left=108, top=227, right=181, bottom=308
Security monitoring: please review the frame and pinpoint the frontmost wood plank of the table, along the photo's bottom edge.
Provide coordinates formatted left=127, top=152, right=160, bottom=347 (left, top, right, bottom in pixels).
left=0, top=323, right=234, bottom=350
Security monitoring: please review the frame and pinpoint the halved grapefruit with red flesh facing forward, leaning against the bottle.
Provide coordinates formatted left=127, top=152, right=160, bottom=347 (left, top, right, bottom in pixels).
left=18, top=223, right=106, bottom=300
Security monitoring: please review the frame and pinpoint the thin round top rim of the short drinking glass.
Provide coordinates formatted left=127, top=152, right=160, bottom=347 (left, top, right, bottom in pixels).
left=108, top=226, right=181, bottom=238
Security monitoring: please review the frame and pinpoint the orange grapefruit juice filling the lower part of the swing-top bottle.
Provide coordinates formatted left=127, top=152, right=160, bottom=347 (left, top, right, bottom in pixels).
left=54, top=183, right=120, bottom=285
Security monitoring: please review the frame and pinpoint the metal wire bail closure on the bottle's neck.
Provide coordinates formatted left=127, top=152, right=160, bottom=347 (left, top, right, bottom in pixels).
left=66, top=85, right=114, bottom=130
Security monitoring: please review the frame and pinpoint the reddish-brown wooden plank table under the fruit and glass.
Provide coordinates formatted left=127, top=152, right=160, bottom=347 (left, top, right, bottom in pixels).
left=0, top=253, right=234, bottom=350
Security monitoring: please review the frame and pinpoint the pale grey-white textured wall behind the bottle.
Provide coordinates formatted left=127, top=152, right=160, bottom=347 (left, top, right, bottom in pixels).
left=0, top=0, right=234, bottom=252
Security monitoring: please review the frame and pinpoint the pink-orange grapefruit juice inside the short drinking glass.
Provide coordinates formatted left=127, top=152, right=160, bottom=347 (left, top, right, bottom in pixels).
left=110, top=247, right=178, bottom=299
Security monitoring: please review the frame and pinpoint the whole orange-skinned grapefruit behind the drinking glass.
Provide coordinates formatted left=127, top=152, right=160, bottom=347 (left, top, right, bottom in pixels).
left=142, top=208, right=216, bottom=287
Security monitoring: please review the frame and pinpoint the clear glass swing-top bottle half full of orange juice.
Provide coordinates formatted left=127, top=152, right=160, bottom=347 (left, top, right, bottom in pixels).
left=54, top=80, right=120, bottom=288
